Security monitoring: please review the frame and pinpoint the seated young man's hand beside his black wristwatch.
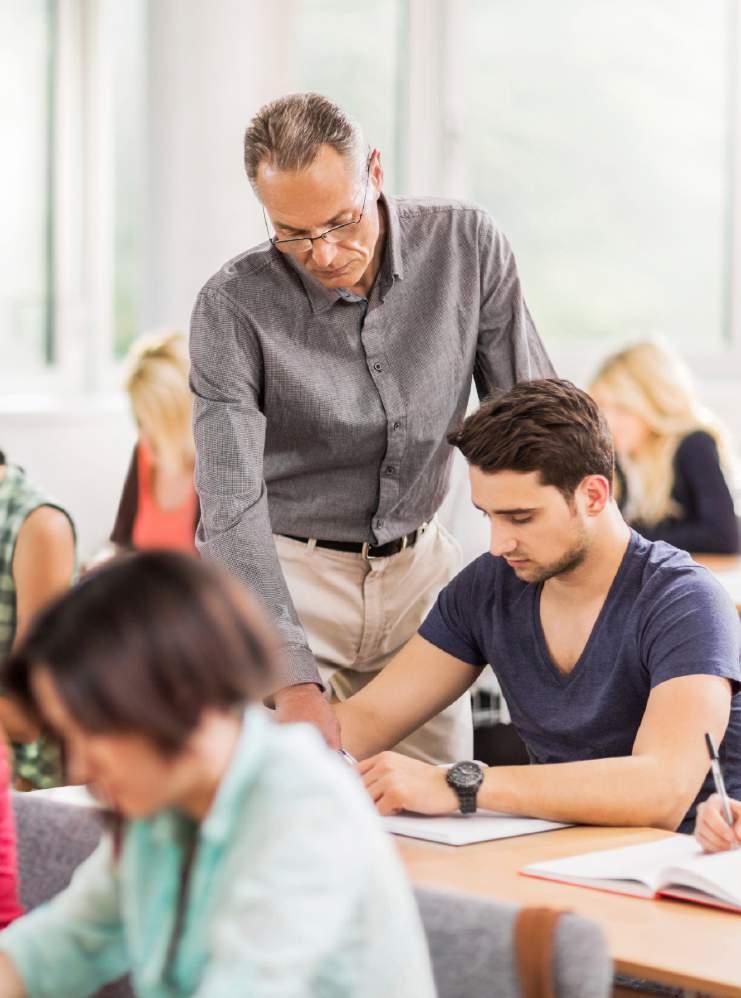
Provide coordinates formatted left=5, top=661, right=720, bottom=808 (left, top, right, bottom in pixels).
left=358, top=752, right=458, bottom=814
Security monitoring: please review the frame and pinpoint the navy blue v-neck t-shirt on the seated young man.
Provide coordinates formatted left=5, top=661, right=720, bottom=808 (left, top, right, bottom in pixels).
left=419, top=531, right=741, bottom=831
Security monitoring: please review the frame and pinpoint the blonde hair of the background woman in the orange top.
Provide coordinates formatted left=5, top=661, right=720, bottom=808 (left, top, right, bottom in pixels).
left=124, top=330, right=195, bottom=470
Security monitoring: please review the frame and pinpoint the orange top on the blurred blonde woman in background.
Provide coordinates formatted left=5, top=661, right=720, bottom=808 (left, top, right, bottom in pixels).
left=131, top=441, right=198, bottom=551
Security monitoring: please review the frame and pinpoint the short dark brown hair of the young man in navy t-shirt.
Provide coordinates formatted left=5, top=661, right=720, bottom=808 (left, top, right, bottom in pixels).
left=448, top=378, right=614, bottom=499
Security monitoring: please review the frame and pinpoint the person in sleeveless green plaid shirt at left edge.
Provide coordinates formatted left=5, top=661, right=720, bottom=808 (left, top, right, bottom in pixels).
left=0, top=453, right=76, bottom=790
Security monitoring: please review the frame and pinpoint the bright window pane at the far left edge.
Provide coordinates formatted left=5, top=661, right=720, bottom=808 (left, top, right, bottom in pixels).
left=0, top=0, right=56, bottom=381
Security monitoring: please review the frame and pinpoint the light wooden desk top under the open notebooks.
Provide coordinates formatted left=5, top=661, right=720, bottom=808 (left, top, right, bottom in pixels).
left=396, top=827, right=741, bottom=996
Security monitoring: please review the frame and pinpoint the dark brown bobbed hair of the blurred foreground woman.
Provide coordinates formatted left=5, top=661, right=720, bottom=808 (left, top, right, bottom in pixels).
left=0, top=551, right=276, bottom=753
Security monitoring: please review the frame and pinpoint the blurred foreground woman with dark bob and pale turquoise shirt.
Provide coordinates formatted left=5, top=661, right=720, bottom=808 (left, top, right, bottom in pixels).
left=0, top=551, right=435, bottom=998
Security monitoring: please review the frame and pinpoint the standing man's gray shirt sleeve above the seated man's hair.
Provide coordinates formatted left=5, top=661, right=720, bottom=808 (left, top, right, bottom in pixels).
left=474, top=212, right=556, bottom=399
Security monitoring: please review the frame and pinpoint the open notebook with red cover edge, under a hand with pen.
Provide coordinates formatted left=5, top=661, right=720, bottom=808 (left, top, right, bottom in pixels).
left=520, top=835, right=741, bottom=912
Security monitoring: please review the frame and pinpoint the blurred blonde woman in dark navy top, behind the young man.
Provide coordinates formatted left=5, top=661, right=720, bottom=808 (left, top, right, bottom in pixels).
left=590, top=342, right=739, bottom=554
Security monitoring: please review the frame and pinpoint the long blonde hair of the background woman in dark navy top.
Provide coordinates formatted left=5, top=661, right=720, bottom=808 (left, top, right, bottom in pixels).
left=590, top=341, right=733, bottom=526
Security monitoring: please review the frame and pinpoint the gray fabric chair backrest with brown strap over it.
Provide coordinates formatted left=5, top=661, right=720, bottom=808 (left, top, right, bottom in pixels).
left=415, top=888, right=613, bottom=998
